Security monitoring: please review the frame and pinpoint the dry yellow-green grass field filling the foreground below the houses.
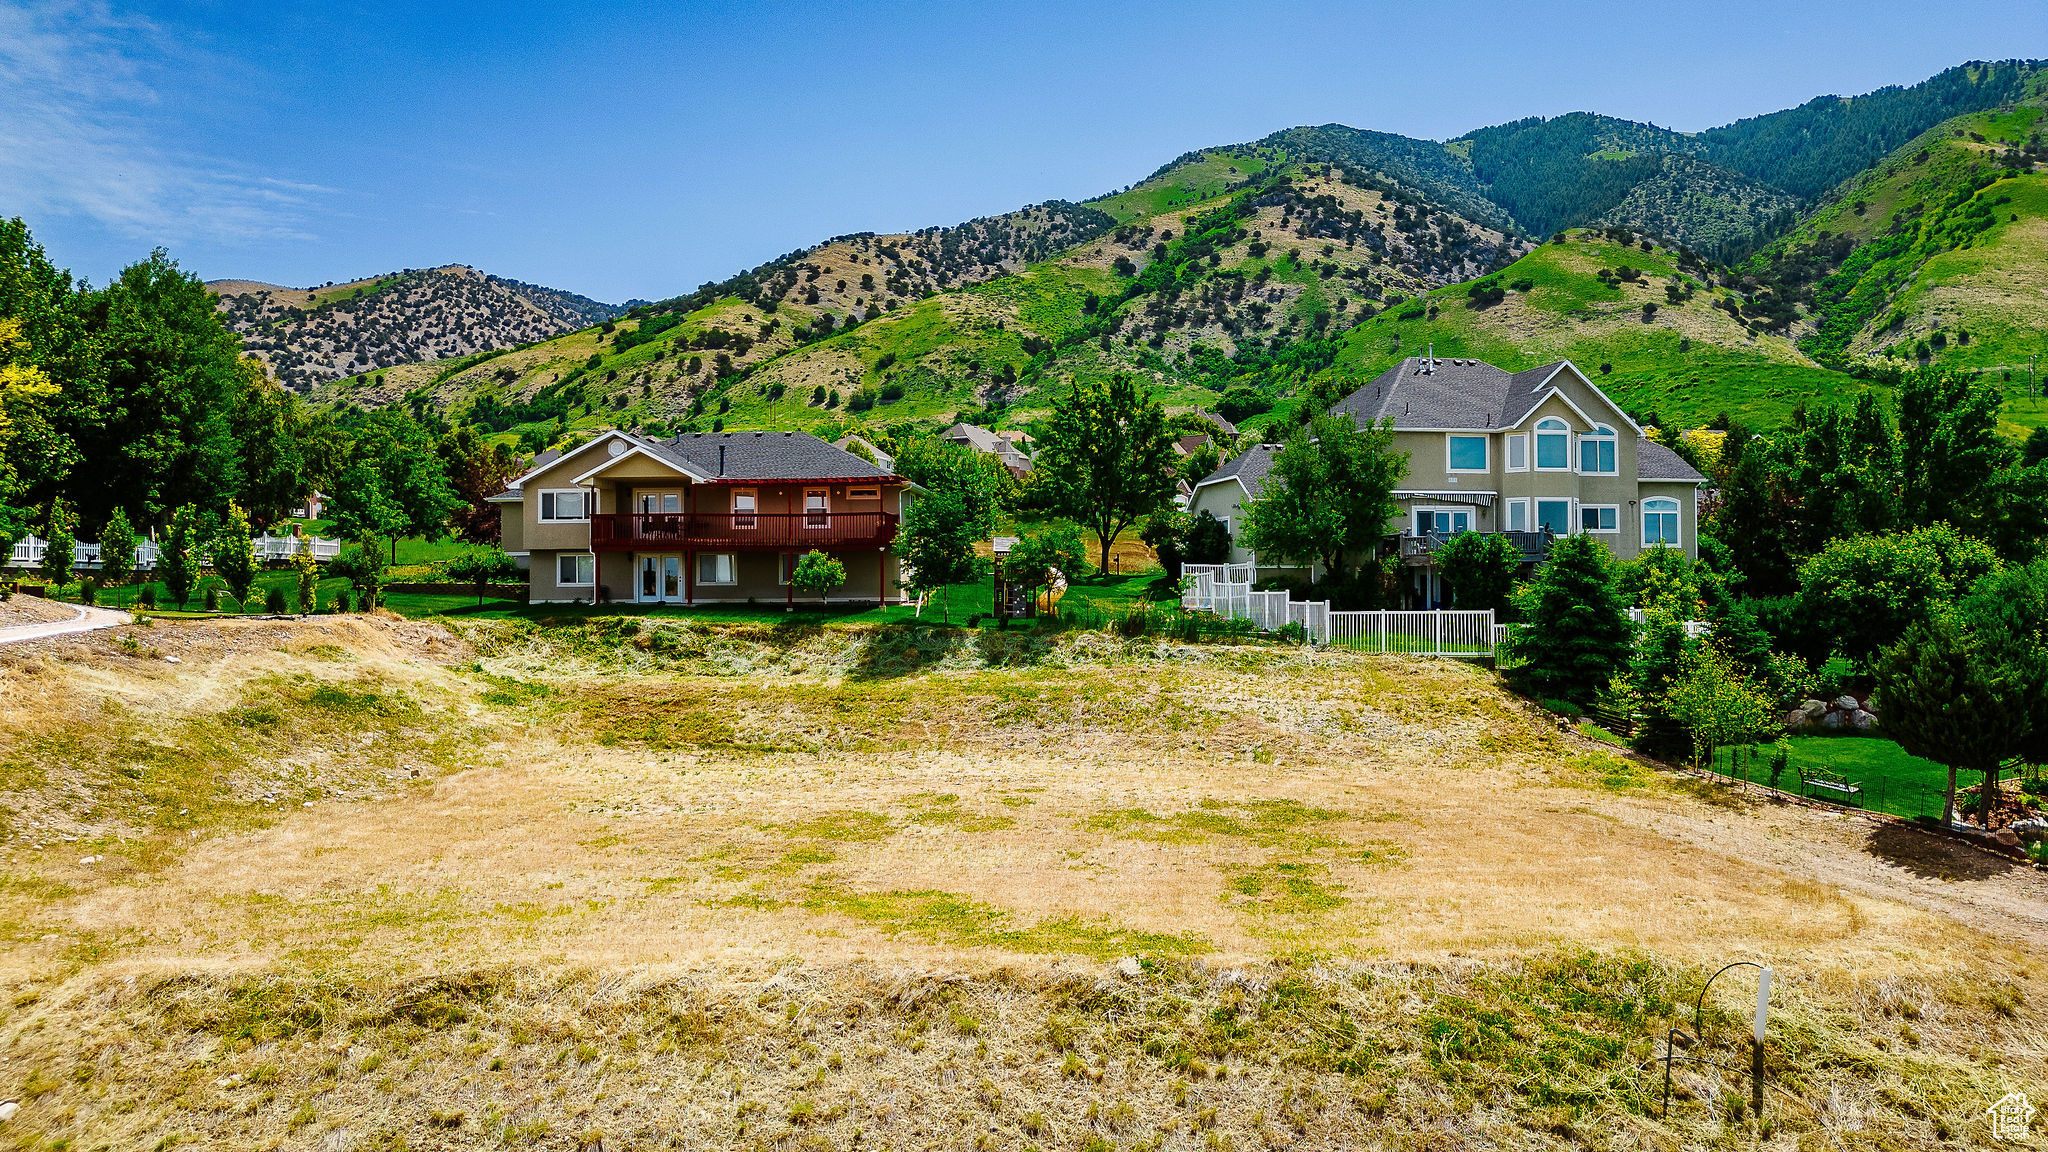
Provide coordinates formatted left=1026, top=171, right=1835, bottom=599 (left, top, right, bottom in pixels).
left=0, top=617, right=2048, bottom=1152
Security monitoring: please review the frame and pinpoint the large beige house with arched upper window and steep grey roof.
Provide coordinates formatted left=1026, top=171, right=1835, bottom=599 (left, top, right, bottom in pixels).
left=1188, top=357, right=1706, bottom=607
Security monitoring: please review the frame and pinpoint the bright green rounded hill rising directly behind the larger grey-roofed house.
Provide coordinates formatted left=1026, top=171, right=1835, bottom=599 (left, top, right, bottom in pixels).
left=1331, top=232, right=1864, bottom=426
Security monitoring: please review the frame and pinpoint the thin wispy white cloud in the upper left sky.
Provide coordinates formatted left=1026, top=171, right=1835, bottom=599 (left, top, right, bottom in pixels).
left=0, top=0, right=330, bottom=246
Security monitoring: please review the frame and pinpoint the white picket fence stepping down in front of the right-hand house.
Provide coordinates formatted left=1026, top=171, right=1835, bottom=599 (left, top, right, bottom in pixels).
left=1180, top=564, right=1507, bottom=656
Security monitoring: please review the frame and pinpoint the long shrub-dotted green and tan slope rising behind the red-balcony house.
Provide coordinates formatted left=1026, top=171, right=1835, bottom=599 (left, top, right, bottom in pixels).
left=322, top=152, right=1526, bottom=441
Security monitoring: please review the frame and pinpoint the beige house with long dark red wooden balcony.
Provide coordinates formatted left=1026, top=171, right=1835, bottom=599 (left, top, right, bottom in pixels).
left=492, top=430, right=909, bottom=605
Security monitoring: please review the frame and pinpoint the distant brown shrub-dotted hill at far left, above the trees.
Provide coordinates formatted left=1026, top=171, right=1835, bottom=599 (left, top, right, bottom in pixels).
left=207, top=264, right=625, bottom=392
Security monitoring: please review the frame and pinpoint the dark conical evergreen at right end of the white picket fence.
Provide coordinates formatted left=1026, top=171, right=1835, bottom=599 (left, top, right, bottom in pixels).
left=1507, top=533, right=1634, bottom=707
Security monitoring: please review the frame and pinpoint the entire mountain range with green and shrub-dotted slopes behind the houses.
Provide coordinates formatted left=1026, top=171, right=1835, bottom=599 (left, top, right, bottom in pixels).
left=260, top=61, right=2048, bottom=445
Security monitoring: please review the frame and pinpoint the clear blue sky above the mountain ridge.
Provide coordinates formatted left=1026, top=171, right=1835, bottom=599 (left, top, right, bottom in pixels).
left=0, top=0, right=2048, bottom=301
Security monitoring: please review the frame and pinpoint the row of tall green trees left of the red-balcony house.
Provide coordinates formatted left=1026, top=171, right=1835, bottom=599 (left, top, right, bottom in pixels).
left=0, top=219, right=518, bottom=569
